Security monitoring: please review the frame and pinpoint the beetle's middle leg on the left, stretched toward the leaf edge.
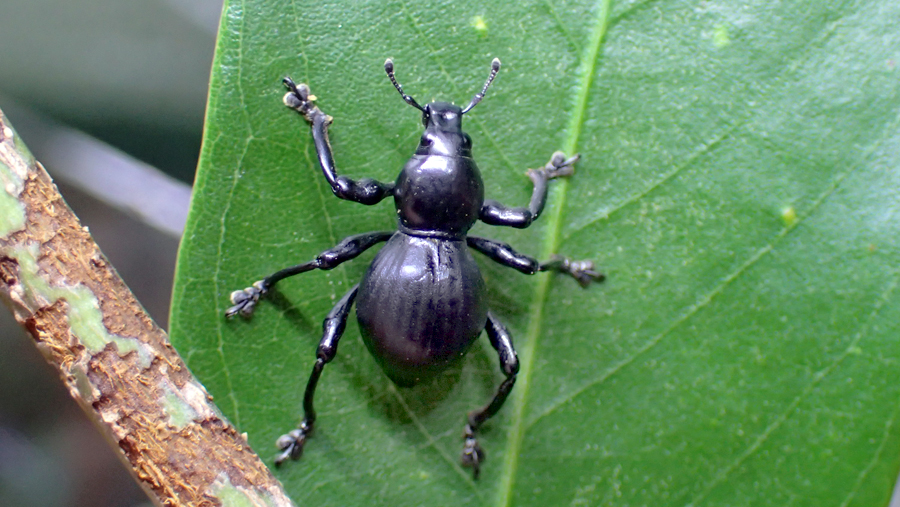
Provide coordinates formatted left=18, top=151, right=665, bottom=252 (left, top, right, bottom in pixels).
left=225, top=231, right=394, bottom=317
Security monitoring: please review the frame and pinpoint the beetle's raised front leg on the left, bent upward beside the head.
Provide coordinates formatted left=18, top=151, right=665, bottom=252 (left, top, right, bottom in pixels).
left=284, top=77, right=394, bottom=205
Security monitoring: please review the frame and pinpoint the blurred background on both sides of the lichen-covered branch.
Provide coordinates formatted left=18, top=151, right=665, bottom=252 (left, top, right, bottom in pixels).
left=0, top=0, right=222, bottom=507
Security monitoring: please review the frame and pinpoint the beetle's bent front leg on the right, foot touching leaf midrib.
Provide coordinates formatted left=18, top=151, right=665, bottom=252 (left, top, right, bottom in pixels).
left=478, top=151, right=579, bottom=229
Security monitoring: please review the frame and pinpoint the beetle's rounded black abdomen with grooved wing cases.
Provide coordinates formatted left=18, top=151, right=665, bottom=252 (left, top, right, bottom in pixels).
left=356, top=232, right=487, bottom=386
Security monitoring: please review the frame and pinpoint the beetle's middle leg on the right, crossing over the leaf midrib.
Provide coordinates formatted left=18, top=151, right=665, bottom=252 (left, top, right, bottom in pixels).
left=466, top=236, right=606, bottom=288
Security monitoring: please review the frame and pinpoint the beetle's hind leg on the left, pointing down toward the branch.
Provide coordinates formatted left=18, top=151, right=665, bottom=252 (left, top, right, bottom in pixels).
left=275, top=284, right=359, bottom=466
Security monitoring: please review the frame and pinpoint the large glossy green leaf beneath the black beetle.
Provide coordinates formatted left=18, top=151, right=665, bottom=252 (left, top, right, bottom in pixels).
left=172, top=0, right=900, bottom=506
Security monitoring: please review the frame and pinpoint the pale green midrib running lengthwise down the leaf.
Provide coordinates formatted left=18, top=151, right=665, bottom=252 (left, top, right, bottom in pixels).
left=497, top=0, right=612, bottom=507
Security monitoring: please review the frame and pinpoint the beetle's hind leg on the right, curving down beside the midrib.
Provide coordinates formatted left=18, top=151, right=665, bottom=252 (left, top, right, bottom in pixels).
left=462, top=312, right=519, bottom=479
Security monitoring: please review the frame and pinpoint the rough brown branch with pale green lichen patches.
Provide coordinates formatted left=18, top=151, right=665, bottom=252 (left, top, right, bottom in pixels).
left=0, top=111, right=293, bottom=506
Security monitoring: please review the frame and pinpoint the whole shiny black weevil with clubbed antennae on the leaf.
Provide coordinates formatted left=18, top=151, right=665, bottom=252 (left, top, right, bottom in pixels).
left=226, top=58, right=604, bottom=478
